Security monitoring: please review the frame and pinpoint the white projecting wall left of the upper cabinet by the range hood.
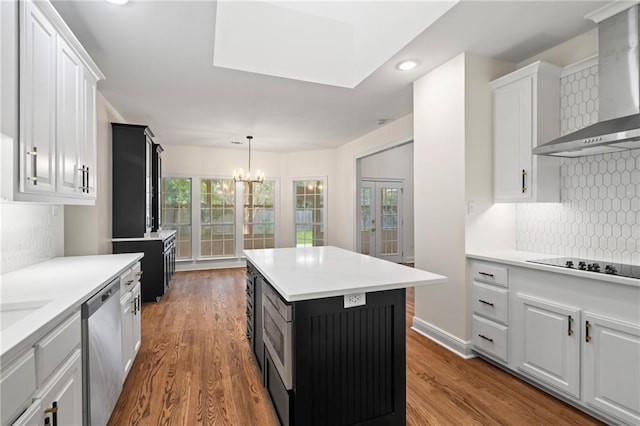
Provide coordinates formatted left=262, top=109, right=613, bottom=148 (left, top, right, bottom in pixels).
left=414, top=54, right=515, bottom=349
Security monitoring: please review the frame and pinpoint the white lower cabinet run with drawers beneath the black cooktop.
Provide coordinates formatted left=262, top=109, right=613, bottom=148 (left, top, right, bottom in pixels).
left=470, top=259, right=640, bottom=426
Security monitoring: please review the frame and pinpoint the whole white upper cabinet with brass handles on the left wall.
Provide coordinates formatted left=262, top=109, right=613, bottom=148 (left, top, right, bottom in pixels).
left=16, top=0, right=104, bottom=204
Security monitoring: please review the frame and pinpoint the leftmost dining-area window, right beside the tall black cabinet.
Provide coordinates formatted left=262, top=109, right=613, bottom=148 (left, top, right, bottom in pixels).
left=161, top=177, right=191, bottom=259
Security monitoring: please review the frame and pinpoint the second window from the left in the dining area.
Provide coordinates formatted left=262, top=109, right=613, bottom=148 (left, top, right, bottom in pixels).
left=200, top=179, right=236, bottom=257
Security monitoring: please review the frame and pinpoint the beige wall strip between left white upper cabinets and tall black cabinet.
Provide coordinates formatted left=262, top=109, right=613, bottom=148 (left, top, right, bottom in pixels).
left=64, top=92, right=125, bottom=256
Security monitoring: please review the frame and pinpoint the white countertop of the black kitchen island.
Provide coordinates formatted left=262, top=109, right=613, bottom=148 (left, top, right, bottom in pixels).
left=244, top=247, right=447, bottom=302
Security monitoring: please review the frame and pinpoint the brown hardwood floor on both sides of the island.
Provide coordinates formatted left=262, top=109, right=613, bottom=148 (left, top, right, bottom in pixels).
left=109, top=269, right=600, bottom=426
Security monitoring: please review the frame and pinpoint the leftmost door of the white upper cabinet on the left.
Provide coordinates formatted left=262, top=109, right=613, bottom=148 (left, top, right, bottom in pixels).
left=19, top=1, right=56, bottom=193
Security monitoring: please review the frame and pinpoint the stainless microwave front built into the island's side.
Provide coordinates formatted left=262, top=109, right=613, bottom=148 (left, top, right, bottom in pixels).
left=260, top=280, right=293, bottom=390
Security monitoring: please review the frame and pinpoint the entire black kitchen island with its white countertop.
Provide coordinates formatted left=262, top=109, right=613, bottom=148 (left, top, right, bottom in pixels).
left=245, top=247, right=446, bottom=425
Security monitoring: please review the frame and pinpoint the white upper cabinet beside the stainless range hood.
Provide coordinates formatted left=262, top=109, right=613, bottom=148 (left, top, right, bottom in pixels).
left=491, top=62, right=561, bottom=203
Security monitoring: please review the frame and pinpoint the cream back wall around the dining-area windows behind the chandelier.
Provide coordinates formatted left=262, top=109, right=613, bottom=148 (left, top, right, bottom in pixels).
left=162, top=120, right=413, bottom=266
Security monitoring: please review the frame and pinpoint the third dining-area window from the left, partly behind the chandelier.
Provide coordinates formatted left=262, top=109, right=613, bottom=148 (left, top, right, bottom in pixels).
left=242, top=181, right=276, bottom=249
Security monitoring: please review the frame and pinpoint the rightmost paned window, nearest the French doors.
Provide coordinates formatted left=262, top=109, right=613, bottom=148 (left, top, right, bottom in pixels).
left=293, top=180, right=325, bottom=247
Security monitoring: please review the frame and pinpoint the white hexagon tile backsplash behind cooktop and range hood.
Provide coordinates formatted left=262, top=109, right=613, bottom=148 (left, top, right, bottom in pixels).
left=516, top=63, right=640, bottom=264
